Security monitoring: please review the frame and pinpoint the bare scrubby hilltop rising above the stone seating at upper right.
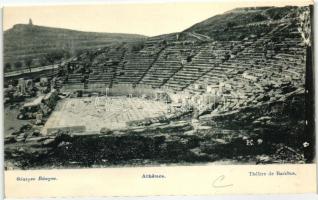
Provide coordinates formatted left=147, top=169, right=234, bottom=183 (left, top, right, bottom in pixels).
left=183, top=6, right=299, bottom=40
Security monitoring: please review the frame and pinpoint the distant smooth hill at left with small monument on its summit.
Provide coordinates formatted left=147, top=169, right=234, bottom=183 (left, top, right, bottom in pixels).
left=4, top=24, right=145, bottom=71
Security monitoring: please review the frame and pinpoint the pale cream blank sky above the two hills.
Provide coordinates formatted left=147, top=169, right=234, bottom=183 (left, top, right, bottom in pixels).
left=3, top=0, right=308, bottom=36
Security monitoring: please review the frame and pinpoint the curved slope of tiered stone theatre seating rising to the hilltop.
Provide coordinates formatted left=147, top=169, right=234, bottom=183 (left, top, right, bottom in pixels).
left=61, top=7, right=310, bottom=96
